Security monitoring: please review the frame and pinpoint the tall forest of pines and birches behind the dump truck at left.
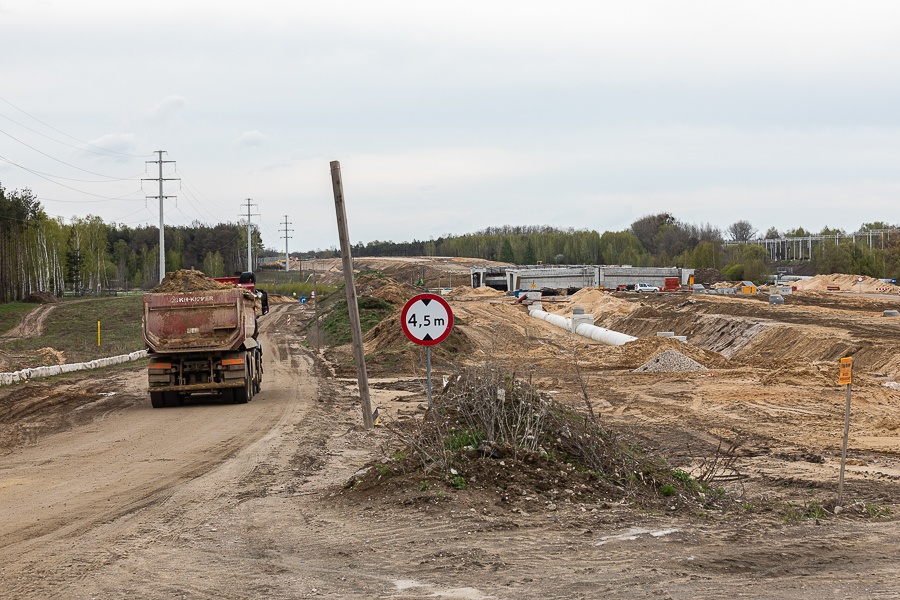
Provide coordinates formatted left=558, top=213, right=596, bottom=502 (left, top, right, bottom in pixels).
left=0, top=185, right=263, bottom=302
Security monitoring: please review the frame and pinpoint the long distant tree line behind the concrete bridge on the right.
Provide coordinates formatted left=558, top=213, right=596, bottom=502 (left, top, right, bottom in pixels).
left=338, top=213, right=900, bottom=281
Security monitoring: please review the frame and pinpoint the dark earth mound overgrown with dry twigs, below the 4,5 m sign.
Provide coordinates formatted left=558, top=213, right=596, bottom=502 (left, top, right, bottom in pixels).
left=339, top=367, right=721, bottom=513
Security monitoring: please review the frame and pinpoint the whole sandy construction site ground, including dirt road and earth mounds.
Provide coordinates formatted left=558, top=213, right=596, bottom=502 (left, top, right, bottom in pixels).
left=0, top=258, right=900, bottom=600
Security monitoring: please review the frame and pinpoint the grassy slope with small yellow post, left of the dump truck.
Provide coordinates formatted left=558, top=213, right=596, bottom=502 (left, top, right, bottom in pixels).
left=0, top=296, right=144, bottom=368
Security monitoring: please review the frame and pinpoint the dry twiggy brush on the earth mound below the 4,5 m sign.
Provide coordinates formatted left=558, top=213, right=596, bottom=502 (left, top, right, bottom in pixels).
left=389, top=365, right=672, bottom=495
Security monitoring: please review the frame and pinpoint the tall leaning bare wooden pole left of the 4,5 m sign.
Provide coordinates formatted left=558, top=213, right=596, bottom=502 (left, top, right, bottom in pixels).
left=330, top=160, right=375, bottom=429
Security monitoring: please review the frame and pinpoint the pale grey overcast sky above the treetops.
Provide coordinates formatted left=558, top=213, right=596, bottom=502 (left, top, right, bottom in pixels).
left=0, top=0, right=900, bottom=251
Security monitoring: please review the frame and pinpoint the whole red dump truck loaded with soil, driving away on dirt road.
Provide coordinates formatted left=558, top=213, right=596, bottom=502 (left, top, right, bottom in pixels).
left=142, top=287, right=263, bottom=408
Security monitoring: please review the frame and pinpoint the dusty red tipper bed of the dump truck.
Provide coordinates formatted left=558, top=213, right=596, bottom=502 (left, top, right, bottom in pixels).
left=141, top=288, right=256, bottom=353
